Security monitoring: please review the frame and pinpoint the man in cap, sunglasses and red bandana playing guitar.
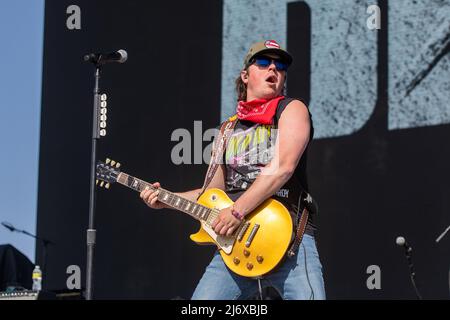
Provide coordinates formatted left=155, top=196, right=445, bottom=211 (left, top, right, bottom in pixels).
left=140, top=40, right=325, bottom=300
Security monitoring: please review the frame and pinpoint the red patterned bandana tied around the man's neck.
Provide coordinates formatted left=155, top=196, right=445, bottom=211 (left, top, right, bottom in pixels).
left=236, top=96, right=284, bottom=124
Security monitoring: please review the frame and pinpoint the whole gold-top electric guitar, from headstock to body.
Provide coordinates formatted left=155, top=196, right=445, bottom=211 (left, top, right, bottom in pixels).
left=96, top=159, right=292, bottom=277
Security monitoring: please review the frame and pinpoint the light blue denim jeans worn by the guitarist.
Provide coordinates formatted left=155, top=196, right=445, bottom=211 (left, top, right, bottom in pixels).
left=192, top=234, right=325, bottom=300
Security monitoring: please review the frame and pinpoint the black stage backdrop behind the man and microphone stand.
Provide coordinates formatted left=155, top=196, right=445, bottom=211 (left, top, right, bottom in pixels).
left=37, top=0, right=450, bottom=299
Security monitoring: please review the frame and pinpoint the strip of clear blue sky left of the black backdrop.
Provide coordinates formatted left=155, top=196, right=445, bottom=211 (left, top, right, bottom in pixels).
left=0, top=0, right=44, bottom=262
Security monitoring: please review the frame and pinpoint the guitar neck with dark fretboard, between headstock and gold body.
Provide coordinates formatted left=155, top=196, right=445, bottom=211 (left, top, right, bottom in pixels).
left=117, top=172, right=215, bottom=224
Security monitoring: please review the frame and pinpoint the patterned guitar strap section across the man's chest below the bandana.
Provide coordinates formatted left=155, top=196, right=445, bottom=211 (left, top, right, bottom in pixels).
left=197, top=115, right=238, bottom=200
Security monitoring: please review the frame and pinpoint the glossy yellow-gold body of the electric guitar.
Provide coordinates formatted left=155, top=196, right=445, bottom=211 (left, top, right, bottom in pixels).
left=191, top=188, right=292, bottom=277
